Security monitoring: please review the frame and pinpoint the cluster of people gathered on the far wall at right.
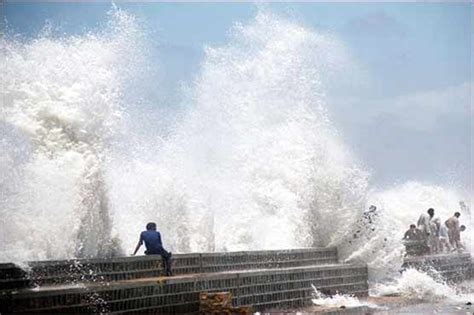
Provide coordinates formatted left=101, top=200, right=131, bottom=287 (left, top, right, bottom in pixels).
left=403, top=208, right=466, bottom=255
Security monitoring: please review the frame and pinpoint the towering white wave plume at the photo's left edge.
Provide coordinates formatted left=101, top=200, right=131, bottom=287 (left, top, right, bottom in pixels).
left=0, top=10, right=145, bottom=260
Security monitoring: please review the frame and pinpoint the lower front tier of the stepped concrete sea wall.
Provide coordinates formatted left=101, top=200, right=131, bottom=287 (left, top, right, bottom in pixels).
left=0, top=264, right=368, bottom=314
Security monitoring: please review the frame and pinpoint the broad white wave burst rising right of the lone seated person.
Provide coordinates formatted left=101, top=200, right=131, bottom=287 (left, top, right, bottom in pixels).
left=111, top=12, right=367, bottom=251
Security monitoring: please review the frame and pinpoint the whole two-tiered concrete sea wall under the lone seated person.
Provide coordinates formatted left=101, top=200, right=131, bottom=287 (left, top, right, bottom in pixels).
left=0, top=248, right=368, bottom=314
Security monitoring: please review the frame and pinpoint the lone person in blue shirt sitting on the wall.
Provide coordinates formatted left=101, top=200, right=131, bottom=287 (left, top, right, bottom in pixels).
left=132, top=222, right=173, bottom=276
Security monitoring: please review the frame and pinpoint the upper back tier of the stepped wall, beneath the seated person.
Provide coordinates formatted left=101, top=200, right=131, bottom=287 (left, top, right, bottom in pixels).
left=0, top=248, right=337, bottom=290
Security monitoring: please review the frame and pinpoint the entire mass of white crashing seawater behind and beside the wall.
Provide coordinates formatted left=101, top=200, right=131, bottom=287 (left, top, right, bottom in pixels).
left=0, top=9, right=473, bottom=304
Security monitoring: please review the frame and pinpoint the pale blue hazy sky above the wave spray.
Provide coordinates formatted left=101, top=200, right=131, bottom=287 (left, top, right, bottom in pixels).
left=3, top=1, right=474, bottom=190
